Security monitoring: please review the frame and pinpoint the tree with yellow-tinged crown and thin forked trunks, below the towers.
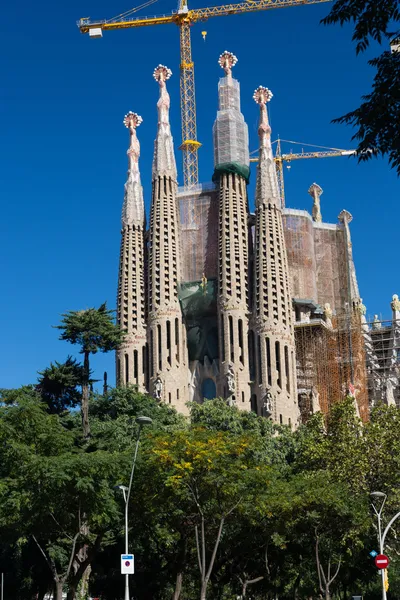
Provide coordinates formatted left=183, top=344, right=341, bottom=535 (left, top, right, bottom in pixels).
left=145, top=428, right=269, bottom=600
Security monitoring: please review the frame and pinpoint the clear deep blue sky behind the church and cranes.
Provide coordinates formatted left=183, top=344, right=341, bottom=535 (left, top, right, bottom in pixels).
left=0, top=0, right=400, bottom=387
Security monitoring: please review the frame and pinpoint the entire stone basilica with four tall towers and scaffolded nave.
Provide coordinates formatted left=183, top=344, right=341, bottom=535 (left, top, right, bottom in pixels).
left=116, top=52, right=400, bottom=426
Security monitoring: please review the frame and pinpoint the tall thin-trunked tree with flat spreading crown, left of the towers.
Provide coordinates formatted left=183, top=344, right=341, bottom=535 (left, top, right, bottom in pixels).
left=56, top=303, right=124, bottom=438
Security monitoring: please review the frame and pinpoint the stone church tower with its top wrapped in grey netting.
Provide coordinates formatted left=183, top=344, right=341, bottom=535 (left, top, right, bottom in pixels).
left=213, top=51, right=250, bottom=410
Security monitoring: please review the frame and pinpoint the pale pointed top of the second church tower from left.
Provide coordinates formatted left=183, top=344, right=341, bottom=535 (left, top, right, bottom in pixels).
left=153, top=65, right=177, bottom=180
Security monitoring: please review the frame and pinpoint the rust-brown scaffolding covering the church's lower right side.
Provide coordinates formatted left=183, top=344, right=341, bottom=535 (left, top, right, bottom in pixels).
left=295, top=310, right=400, bottom=421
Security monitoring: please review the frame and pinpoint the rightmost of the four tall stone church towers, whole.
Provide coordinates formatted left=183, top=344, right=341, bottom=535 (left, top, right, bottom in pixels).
left=250, top=86, right=299, bottom=424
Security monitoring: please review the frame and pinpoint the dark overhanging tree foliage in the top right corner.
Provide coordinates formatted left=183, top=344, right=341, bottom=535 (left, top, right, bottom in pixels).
left=322, top=0, right=400, bottom=174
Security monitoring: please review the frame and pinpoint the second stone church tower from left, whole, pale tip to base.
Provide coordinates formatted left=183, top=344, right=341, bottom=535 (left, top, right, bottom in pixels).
left=148, top=65, right=189, bottom=412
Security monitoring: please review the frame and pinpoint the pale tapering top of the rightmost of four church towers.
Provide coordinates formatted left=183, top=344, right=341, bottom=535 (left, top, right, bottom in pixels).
left=253, top=85, right=280, bottom=206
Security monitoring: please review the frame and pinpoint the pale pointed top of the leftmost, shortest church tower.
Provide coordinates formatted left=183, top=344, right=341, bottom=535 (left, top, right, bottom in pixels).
left=122, top=111, right=144, bottom=225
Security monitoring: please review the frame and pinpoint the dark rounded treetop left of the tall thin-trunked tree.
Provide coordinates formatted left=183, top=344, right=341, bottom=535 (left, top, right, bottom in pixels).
left=36, top=356, right=85, bottom=413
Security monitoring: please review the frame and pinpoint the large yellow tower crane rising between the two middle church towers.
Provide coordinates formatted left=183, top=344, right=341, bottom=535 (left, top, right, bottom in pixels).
left=78, top=0, right=330, bottom=188
